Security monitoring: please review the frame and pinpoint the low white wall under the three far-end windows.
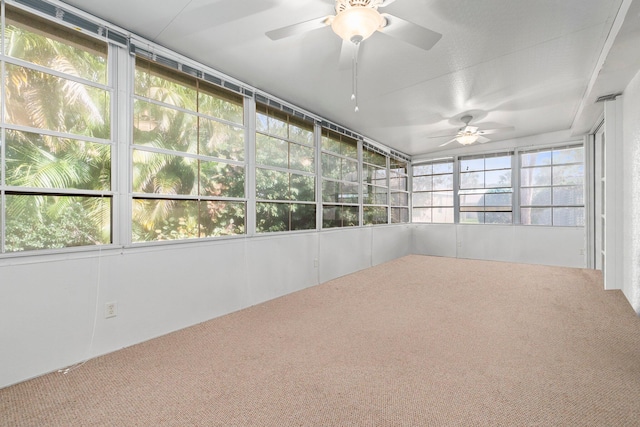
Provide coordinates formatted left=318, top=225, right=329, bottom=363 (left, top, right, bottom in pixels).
left=412, top=224, right=586, bottom=268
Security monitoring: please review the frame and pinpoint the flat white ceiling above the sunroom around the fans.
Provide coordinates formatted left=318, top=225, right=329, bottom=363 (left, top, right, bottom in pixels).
left=65, top=0, right=640, bottom=155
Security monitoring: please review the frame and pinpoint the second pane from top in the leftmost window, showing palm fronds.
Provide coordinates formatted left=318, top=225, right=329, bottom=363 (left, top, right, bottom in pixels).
left=5, top=63, right=111, bottom=139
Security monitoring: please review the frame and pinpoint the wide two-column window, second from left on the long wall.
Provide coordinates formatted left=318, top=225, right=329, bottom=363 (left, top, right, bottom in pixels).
left=131, top=58, right=246, bottom=243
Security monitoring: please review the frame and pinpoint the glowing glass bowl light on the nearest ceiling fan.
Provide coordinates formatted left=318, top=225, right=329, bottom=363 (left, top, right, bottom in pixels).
left=331, top=6, right=385, bottom=44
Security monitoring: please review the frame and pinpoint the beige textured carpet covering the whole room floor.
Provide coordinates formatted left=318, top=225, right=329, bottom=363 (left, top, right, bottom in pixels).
left=0, top=256, right=640, bottom=426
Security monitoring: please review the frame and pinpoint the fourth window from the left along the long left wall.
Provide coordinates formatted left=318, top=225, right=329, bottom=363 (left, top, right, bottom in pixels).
left=321, top=129, right=360, bottom=228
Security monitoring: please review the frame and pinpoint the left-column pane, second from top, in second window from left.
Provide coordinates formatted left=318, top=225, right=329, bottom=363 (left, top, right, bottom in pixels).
left=133, top=99, right=198, bottom=154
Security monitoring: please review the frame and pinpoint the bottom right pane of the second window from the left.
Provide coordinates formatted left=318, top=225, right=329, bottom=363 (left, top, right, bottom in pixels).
left=200, top=200, right=246, bottom=237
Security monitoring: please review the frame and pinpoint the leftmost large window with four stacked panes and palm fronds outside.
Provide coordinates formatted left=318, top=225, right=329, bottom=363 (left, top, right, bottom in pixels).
left=0, top=5, right=114, bottom=253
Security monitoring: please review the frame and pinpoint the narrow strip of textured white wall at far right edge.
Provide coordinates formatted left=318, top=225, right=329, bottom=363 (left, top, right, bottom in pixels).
left=618, top=67, right=640, bottom=315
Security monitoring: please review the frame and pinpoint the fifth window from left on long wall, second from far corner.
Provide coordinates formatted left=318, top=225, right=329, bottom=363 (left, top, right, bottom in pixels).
left=362, top=147, right=389, bottom=225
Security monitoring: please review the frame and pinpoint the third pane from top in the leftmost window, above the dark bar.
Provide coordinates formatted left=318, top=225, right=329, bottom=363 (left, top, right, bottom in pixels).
left=5, top=130, right=111, bottom=190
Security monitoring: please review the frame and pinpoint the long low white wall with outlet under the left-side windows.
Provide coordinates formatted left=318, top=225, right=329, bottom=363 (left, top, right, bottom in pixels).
left=0, top=225, right=411, bottom=387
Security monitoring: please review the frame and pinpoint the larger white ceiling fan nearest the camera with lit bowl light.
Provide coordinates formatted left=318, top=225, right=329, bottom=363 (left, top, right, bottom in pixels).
left=266, top=0, right=442, bottom=50
